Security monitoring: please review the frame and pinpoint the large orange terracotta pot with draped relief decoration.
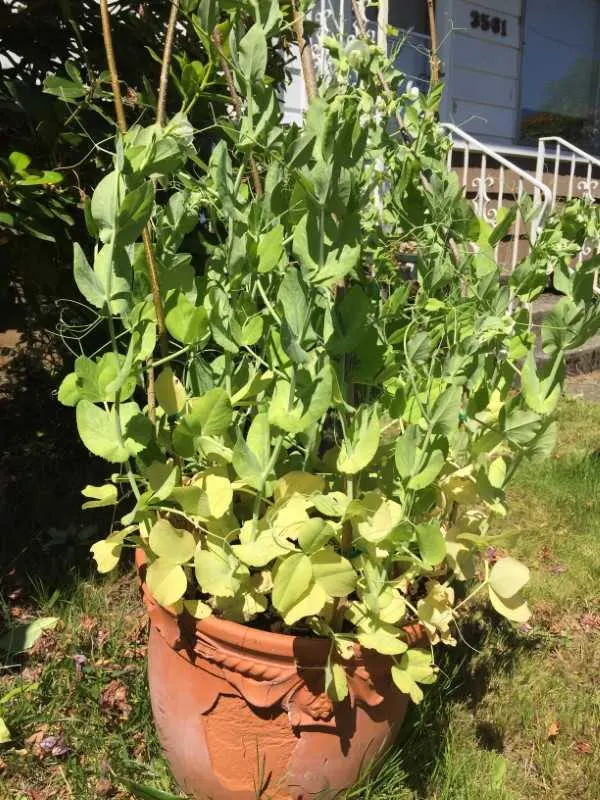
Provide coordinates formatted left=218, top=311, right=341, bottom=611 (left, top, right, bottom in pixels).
left=136, top=550, right=424, bottom=800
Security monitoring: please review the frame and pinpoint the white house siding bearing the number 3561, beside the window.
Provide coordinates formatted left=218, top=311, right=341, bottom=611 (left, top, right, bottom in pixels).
left=438, top=0, right=522, bottom=144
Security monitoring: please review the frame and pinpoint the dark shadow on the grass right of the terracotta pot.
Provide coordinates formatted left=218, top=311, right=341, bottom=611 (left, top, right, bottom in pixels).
left=346, top=609, right=541, bottom=800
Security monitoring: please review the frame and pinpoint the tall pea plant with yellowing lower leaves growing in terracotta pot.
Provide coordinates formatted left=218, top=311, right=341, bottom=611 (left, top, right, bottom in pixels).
left=59, top=0, right=600, bottom=702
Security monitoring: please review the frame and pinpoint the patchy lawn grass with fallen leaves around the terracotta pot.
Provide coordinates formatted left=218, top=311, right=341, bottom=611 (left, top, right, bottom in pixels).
left=0, top=400, right=600, bottom=800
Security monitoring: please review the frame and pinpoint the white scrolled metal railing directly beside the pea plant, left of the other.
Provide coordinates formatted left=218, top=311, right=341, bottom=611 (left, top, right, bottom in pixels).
left=441, top=122, right=552, bottom=271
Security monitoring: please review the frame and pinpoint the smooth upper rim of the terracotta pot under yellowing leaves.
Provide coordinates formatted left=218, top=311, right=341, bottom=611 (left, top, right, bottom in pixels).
left=135, top=547, right=427, bottom=659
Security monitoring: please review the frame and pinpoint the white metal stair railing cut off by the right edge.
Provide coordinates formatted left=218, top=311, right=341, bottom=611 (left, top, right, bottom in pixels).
left=535, top=136, right=600, bottom=209
